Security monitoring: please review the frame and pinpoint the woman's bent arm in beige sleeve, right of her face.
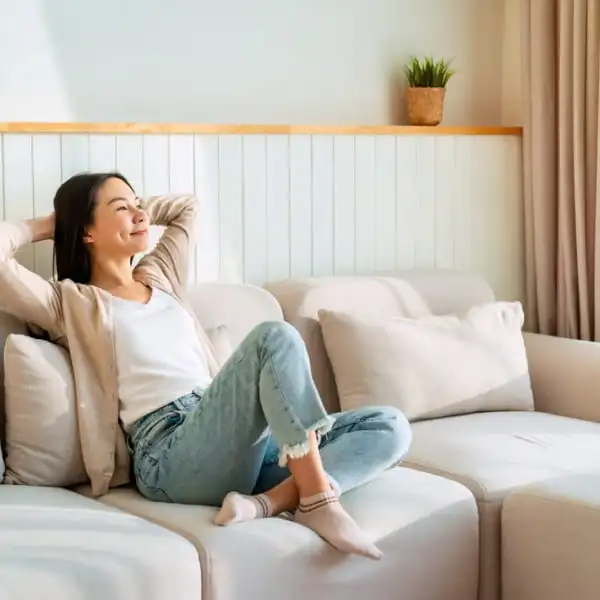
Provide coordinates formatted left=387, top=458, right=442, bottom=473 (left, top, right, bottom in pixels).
left=137, top=194, right=198, bottom=287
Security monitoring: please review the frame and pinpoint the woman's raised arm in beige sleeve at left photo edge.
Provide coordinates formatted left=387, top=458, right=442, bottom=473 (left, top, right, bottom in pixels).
left=0, top=215, right=62, bottom=335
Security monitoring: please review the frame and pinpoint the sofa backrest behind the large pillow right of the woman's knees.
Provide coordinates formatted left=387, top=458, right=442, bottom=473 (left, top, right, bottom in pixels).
left=265, top=270, right=495, bottom=412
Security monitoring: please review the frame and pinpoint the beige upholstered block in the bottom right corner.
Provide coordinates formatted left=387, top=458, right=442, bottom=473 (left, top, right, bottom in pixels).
left=502, top=472, right=600, bottom=600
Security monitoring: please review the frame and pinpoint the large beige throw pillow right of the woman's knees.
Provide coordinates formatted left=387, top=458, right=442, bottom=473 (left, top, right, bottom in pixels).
left=319, top=302, right=533, bottom=421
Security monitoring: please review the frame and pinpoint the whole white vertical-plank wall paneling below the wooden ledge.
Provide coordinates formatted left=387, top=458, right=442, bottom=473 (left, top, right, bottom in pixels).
left=0, top=132, right=524, bottom=299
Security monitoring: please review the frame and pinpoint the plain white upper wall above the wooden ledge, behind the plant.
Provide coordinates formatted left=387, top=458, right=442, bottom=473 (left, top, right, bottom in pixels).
left=0, top=0, right=518, bottom=125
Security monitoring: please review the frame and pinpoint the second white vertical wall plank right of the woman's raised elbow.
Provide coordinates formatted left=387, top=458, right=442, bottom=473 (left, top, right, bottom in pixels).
left=219, top=135, right=244, bottom=281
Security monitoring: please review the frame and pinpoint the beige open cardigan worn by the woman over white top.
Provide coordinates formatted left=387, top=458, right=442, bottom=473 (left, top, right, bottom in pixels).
left=0, top=195, right=218, bottom=496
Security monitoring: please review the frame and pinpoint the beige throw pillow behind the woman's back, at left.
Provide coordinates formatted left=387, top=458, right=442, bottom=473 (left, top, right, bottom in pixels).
left=4, top=335, right=88, bottom=487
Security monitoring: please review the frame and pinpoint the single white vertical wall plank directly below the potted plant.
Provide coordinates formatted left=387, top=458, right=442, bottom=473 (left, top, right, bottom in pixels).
left=415, top=136, right=436, bottom=269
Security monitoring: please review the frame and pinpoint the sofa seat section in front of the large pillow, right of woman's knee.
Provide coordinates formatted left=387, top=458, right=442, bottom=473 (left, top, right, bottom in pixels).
left=404, top=412, right=600, bottom=600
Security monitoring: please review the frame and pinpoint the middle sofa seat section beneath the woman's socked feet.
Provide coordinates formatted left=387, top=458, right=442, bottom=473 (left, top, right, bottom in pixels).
left=78, top=468, right=477, bottom=600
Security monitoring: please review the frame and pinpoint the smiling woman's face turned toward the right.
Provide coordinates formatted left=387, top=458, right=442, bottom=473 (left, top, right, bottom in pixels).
left=84, top=177, right=149, bottom=260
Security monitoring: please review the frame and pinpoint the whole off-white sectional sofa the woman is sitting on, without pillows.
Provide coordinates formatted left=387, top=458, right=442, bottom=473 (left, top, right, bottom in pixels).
left=0, top=271, right=600, bottom=600
